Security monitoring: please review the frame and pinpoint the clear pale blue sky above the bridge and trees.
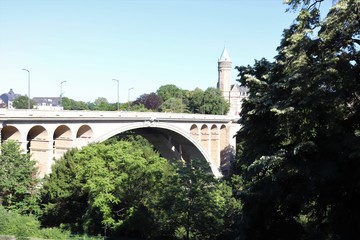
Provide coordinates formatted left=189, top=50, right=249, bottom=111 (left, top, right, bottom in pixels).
left=0, top=0, right=332, bottom=102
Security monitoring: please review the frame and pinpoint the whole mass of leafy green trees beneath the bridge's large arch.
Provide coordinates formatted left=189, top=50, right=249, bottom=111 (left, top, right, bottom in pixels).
left=41, top=136, right=240, bottom=239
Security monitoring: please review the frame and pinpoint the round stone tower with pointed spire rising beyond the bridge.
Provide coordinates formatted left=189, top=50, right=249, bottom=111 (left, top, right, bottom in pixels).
left=217, top=47, right=232, bottom=102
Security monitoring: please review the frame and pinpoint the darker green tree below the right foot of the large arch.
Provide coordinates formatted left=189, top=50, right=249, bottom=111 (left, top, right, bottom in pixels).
left=153, top=160, right=241, bottom=239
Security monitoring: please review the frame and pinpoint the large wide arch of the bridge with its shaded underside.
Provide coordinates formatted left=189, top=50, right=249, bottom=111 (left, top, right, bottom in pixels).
left=93, top=122, right=221, bottom=177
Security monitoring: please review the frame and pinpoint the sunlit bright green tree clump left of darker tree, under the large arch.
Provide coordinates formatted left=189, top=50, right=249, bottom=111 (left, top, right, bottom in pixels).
left=42, top=140, right=174, bottom=237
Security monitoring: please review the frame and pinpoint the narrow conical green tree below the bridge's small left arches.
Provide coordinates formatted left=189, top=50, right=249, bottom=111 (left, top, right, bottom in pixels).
left=41, top=149, right=88, bottom=233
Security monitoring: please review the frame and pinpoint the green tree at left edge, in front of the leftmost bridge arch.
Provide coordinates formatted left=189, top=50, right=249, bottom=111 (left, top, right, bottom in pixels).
left=0, top=141, right=39, bottom=213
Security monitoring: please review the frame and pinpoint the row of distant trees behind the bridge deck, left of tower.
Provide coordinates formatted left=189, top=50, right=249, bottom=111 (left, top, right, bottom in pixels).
left=62, top=84, right=229, bottom=115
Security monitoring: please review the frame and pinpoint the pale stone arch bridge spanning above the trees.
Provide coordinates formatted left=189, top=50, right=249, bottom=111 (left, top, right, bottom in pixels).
left=0, top=109, right=240, bottom=176
